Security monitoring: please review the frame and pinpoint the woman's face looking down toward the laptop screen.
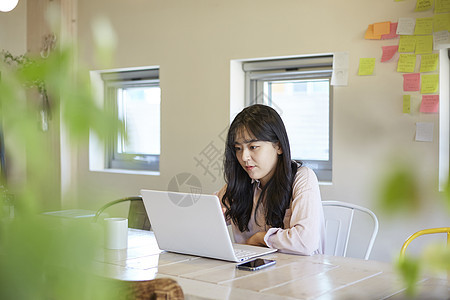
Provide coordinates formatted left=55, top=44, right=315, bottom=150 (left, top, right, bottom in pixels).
left=235, top=130, right=283, bottom=186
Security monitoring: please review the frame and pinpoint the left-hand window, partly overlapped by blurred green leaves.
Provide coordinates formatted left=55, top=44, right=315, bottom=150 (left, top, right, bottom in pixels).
left=101, top=69, right=161, bottom=171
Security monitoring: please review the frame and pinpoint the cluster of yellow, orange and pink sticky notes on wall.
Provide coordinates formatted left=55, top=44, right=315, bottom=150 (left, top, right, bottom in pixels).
left=364, top=0, right=450, bottom=119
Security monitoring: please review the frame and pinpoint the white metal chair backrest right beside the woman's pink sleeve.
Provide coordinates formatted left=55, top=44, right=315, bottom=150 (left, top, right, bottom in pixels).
left=322, top=201, right=378, bottom=260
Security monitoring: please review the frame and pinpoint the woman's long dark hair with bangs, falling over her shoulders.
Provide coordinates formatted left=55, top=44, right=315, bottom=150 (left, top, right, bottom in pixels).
left=222, top=104, right=298, bottom=232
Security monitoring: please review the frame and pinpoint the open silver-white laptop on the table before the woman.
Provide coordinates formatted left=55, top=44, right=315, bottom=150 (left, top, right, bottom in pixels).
left=141, top=189, right=277, bottom=262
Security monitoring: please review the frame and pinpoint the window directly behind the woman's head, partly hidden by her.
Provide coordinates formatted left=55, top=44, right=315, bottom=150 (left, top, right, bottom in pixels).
left=243, top=55, right=333, bottom=181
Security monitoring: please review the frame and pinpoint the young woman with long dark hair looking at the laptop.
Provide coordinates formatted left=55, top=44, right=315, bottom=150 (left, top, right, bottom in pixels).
left=218, top=104, right=325, bottom=255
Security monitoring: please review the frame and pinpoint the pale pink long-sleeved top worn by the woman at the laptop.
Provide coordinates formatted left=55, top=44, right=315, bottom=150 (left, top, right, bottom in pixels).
left=218, top=167, right=325, bottom=255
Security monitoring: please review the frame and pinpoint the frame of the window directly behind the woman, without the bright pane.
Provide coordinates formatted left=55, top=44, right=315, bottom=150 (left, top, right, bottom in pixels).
left=242, top=55, right=333, bottom=182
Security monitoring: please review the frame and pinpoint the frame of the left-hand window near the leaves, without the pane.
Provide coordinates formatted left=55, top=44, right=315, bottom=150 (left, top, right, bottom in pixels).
left=101, top=68, right=161, bottom=172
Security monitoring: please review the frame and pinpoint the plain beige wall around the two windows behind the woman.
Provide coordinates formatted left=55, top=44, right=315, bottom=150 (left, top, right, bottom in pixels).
left=76, top=0, right=448, bottom=261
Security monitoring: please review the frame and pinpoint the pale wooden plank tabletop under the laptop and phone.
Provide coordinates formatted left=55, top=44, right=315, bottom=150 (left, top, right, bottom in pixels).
left=96, top=229, right=450, bottom=300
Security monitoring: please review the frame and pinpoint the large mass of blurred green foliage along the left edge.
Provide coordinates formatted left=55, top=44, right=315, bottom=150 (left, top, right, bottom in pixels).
left=0, top=34, right=121, bottom=299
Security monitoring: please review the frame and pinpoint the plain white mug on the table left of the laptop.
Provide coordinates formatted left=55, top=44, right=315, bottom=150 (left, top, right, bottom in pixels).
left=104, top=218, right=128, bottom=249
